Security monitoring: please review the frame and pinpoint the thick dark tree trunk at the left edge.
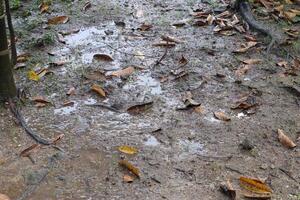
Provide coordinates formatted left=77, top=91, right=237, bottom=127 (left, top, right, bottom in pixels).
left=0, top=0, right=17, bottom=99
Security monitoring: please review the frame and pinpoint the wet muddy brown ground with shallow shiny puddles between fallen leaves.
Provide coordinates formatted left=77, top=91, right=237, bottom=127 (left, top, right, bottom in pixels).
left=0, top=0, right=300, bottom=200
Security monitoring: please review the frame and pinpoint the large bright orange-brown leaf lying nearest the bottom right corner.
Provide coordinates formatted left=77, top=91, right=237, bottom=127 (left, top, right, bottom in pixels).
left=239, top=176, right=272, bottom=194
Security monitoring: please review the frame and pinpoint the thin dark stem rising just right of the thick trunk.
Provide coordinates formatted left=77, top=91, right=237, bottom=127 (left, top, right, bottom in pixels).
left=4, top=0, right=17, bottom=65
